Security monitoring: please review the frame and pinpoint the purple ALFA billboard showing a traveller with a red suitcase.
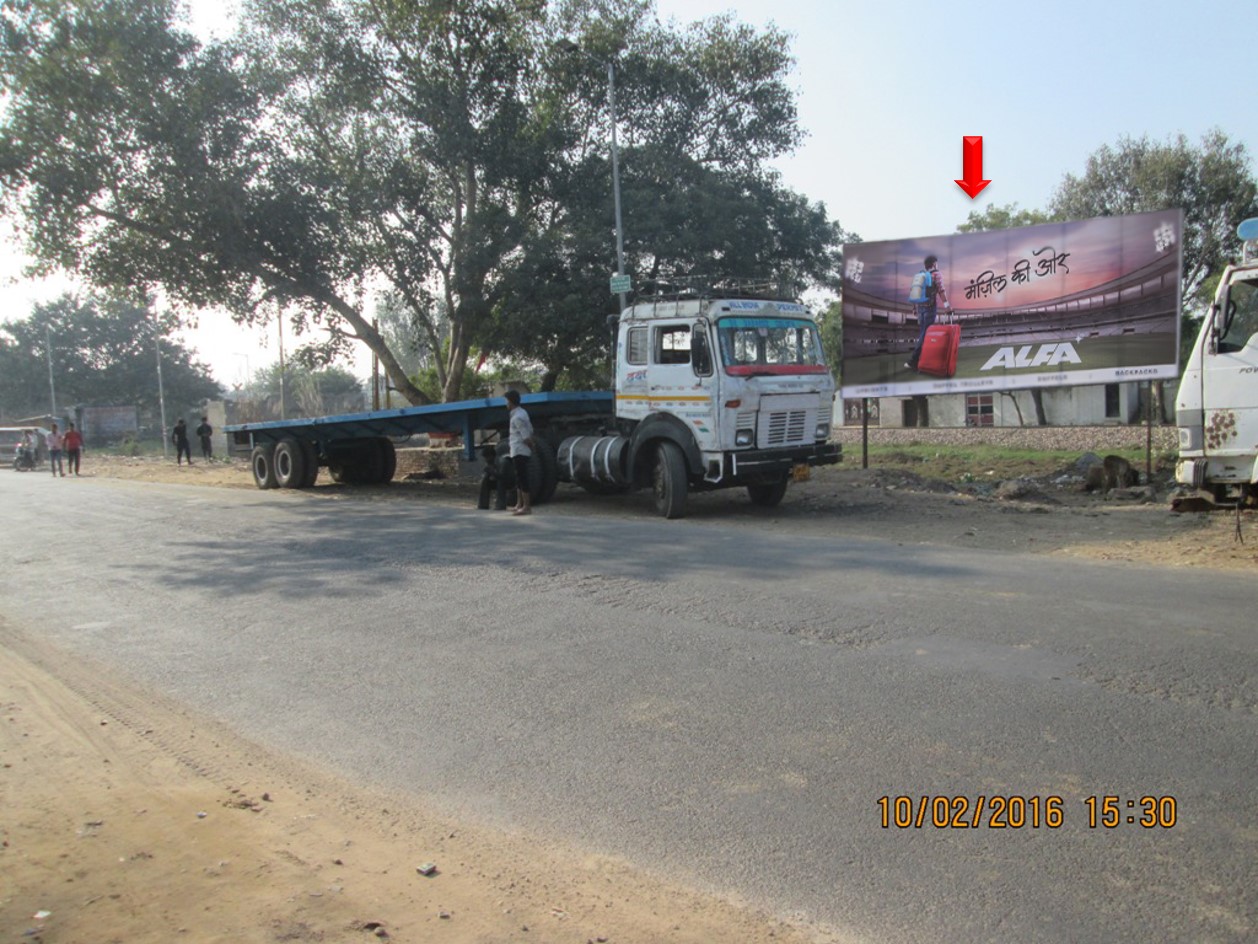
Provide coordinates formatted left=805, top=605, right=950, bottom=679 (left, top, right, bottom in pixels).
left=842, top=209, right=1184, bottom=398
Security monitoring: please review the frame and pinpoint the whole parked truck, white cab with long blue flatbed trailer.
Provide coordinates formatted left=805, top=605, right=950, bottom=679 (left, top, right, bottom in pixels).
left=225, top=288, right=842, bottom=519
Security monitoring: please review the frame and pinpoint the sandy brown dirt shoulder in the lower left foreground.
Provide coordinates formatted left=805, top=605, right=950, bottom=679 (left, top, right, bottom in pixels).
left=0, top=623, right=814, bottom=944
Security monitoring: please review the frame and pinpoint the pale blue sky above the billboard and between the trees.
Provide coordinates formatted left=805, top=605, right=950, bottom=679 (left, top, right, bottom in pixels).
left=0, top=0, right=1258, bottom=385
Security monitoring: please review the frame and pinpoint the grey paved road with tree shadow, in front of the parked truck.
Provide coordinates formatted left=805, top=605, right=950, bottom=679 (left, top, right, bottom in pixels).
left=0, top=473, right=1258, bottom=944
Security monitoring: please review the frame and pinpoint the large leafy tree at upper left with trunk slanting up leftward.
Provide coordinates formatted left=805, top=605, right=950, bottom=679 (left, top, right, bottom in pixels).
left=0, top=0, right=427, bottom=400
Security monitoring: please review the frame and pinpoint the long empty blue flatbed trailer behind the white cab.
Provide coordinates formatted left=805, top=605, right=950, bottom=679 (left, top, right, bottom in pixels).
left=225, top=390, right=615, bottom=501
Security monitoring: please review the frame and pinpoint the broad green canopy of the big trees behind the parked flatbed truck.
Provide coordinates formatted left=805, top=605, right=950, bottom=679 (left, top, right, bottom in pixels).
left=0, top=0, right=843, bottom=402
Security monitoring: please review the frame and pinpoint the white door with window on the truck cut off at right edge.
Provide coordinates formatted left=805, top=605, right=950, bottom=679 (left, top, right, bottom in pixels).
left=1201, top=273, right=1258, bottom=456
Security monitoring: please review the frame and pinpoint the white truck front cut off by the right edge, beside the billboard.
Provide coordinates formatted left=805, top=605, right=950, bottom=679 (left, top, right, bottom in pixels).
left=1175, top=219, right=1258, bottom=506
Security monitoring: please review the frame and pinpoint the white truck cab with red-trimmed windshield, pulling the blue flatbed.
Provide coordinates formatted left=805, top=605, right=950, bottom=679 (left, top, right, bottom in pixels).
left=559, top=293, right=840, bottom=517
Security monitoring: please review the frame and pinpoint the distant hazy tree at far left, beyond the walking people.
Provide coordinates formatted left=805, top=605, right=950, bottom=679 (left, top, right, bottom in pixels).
left=0, top=295, right=220, bottom=413
